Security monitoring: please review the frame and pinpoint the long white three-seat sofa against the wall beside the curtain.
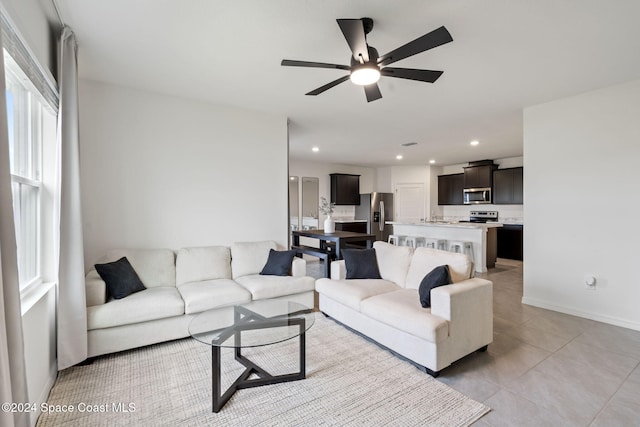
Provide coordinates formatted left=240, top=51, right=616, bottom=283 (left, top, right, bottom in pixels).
left=85, top=241, right=315, bottom=357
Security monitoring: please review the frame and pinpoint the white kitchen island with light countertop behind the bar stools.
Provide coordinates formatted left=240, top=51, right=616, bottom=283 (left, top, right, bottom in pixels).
left=387, top=221, right=502, bottom=273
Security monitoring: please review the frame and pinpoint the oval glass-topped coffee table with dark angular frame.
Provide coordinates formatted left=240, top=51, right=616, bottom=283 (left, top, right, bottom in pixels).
left=189, top=300, right=315, bottom=412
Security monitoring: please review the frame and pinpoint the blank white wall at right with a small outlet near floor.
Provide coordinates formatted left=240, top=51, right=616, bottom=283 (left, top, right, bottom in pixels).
left=523, top=80, right=640, bottom=330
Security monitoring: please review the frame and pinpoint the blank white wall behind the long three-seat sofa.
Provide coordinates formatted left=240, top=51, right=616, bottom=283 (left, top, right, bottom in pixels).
left=79, top=81, right=288, bottom=266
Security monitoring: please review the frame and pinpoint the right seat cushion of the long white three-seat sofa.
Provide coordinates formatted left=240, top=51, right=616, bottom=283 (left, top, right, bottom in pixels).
left=235, top=274, right=315, bottom=300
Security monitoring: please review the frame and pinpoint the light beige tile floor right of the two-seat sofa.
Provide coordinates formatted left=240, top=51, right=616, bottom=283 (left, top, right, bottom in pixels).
left=307, top=259, right=640, bottom=427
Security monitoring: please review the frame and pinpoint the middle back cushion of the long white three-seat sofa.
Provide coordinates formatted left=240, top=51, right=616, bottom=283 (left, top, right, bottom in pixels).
left=176, top=246, right=231, bottom=286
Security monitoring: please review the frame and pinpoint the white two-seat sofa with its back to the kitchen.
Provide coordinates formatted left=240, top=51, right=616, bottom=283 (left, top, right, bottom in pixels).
left=316, top=242, right=493, bottom=376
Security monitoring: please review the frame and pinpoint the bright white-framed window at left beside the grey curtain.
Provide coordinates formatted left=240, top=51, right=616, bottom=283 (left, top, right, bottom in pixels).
left=4, top=50, right=54, bottom=289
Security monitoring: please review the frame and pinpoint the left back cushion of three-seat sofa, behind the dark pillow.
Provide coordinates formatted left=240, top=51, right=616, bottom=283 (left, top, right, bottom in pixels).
left=99, top=249, right=176, bottom=288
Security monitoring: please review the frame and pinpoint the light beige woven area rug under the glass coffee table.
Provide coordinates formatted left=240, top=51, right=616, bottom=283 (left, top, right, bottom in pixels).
left=38, top=313, right=490, bottom=427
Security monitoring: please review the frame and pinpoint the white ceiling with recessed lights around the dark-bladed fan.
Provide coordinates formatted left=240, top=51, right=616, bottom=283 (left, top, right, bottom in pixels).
left=56, top=0, right=640, bottom=166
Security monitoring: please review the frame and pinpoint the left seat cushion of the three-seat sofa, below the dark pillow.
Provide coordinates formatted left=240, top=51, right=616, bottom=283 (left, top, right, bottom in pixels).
left=87, top=286, right=184, bottom=330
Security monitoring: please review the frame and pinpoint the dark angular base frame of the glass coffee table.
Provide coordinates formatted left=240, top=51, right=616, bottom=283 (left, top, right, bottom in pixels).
left=211, top=306, right=306, bottom=412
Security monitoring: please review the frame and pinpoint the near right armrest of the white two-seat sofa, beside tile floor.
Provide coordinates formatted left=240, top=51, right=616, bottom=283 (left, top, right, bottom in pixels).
left=431, top=277, right=493, bottom=346
